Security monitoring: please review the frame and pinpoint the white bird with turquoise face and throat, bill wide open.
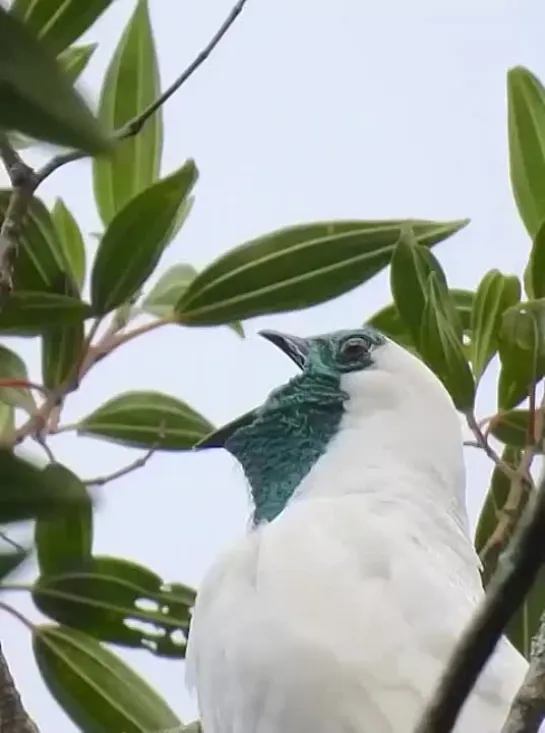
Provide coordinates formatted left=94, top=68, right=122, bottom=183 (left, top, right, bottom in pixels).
left=186, top=326, right=528, bottom=733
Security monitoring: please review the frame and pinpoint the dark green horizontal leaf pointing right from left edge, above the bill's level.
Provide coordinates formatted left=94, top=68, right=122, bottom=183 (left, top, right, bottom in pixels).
left=0, top=290, right=92, bottom=336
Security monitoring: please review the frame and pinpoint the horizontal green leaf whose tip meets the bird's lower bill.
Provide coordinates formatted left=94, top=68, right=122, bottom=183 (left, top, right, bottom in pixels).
left=78, top=392, right=214, bottom=451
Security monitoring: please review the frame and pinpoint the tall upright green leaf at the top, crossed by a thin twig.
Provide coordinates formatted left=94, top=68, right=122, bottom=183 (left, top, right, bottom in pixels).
left=92, top=0, right=163, bottom=224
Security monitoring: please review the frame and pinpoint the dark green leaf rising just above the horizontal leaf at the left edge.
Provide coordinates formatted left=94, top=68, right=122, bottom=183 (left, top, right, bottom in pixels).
left=0, top=189, right=74, bottom=293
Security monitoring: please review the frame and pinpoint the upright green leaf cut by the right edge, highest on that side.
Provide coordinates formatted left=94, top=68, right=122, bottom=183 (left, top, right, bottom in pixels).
left=507, top=66, right=545, bottom=239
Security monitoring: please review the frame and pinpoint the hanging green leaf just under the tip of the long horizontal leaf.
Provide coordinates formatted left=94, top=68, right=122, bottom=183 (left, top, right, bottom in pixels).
left=390, top=229, right=447, bottom=347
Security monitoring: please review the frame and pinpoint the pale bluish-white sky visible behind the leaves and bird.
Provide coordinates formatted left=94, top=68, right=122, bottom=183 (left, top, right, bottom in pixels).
left=1, top=0, right=545, bottom=733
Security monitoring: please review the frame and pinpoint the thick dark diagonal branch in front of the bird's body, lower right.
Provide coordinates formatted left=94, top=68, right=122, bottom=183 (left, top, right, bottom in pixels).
left=416, top=468, right=545, bottom=733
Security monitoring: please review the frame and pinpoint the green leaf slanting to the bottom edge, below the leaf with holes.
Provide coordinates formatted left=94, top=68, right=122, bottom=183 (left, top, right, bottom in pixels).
left=33, top=625, right=181, bottom=733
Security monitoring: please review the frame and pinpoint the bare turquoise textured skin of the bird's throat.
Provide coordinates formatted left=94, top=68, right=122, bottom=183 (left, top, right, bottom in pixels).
left=225, top=373, right=346, bottom=525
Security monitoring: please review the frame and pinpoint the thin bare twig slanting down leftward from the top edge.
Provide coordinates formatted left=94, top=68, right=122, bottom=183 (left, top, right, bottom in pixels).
left=37, top=0, right=251, bottom=183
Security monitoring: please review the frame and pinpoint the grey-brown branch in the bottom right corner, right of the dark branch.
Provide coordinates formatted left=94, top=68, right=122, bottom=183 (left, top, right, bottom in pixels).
left=501, top=613, right=545, bottom=733
